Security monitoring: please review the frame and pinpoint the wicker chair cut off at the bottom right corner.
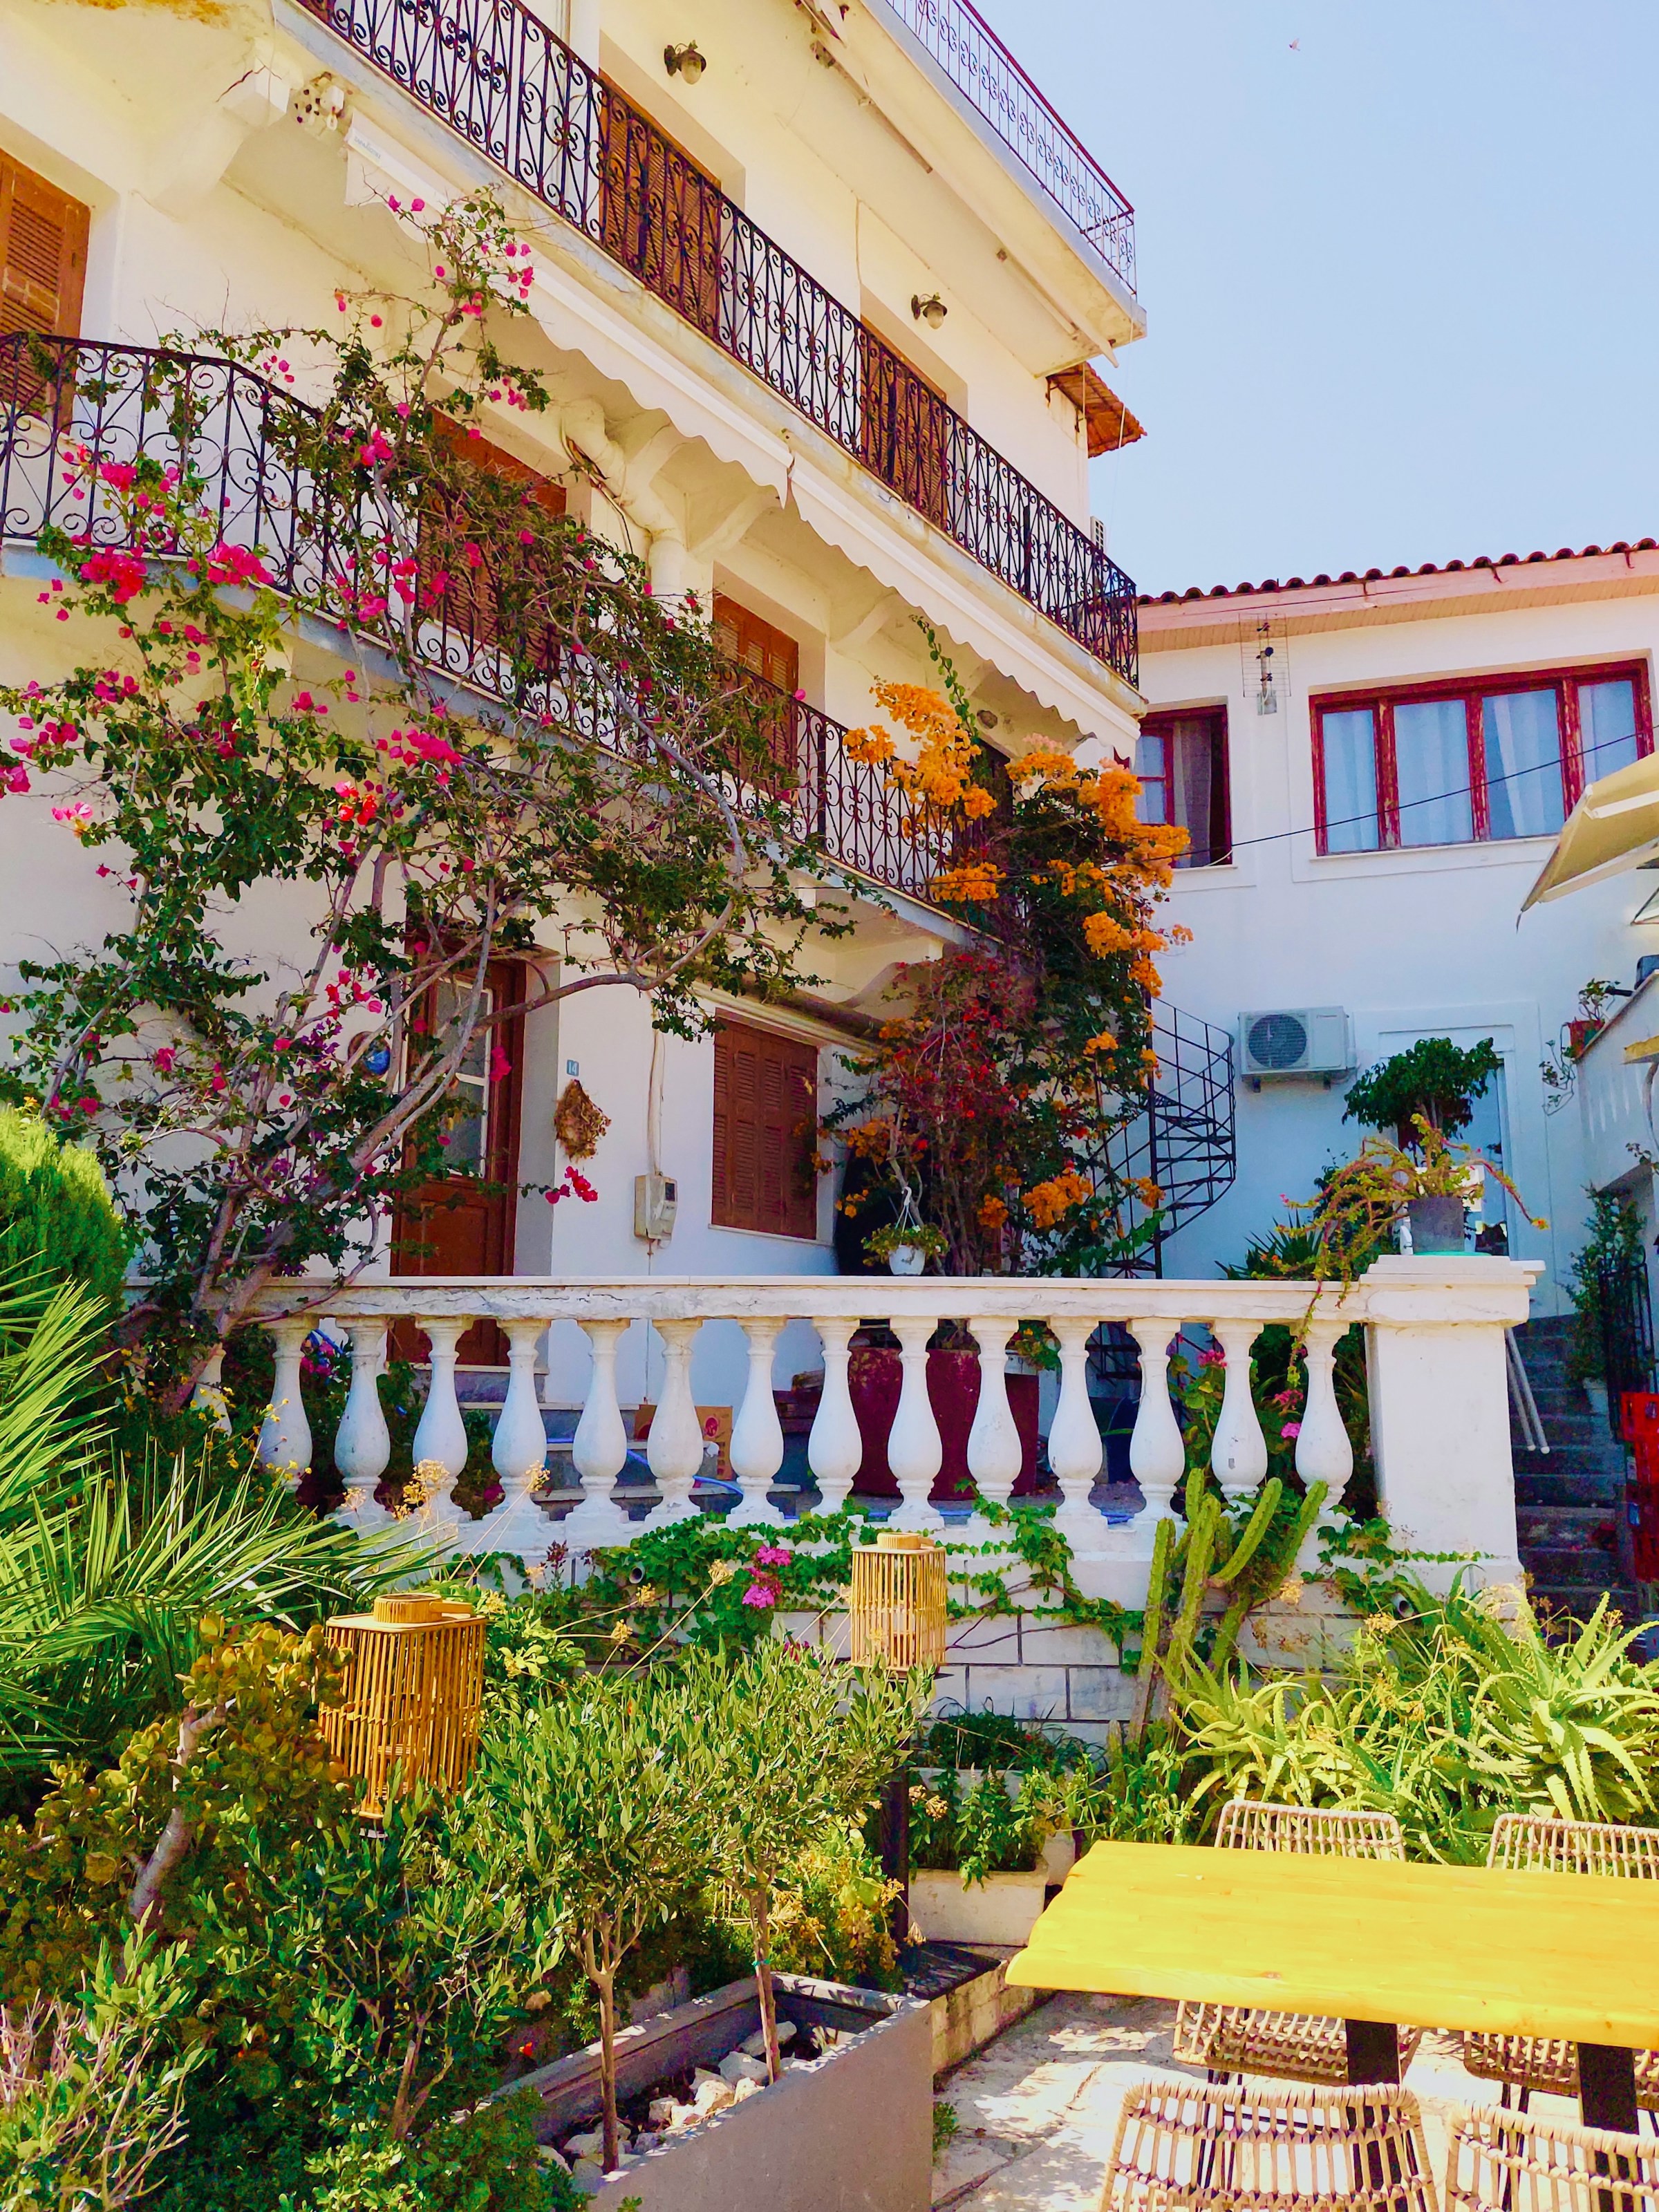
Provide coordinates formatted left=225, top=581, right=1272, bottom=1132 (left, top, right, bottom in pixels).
left=1447, top=2097, right=1659, bottom=2212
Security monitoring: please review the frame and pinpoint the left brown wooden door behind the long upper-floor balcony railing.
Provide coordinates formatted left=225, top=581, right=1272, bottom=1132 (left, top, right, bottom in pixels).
left=599, top=84, right=726, bottom=339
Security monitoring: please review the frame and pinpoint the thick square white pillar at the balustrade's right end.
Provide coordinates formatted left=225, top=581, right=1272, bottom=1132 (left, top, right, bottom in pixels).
left=1362, top=1254, right=1541, bottom=1591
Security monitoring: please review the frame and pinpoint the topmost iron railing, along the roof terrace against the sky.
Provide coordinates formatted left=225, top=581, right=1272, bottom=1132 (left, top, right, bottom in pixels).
left=878, top=0, right=1135, bottom=292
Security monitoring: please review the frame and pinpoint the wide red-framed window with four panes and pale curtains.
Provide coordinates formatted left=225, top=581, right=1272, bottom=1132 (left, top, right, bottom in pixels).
left=1309, top=662, right=1652, bottom=852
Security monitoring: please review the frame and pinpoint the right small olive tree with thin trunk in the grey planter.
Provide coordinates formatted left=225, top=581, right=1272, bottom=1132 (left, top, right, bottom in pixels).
left=686, top=1637, right=931, bottom=2081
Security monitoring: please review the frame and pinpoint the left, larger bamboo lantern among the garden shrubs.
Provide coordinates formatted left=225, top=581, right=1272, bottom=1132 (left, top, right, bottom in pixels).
left=321, top=1597, right=485, bottom=1818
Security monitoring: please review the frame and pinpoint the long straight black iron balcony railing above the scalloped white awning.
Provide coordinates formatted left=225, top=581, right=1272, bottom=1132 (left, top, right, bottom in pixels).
left=292, top=0, right=1137, bottom=684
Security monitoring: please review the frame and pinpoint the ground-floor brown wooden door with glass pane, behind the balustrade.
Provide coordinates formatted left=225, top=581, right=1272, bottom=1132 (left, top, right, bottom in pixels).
left=391, top=960, right=524, bottom=1367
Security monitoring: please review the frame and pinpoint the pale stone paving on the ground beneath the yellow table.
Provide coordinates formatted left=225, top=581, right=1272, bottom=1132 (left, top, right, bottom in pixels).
left=933, top=1998, right=1577, bottom=2212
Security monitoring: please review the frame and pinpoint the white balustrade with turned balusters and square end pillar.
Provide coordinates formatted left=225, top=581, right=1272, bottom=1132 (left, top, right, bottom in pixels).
left=259, top=1257, right=1537, bottom=1604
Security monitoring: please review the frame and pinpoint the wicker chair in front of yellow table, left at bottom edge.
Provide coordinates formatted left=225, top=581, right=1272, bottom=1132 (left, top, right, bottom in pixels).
left=1099, top=2077, right=1438, bottom=2212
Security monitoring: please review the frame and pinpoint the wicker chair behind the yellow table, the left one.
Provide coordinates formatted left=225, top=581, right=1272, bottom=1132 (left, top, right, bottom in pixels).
left=1174, top=1799, right=1423, bottom=2083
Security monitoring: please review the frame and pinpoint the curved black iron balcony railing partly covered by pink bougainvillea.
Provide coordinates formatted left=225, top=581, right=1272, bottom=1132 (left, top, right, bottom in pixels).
left=0, top=334, right=986, bottom=898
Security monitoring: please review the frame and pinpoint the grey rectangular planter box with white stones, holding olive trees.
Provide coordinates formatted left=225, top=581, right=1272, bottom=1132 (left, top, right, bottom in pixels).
left=500, top=1973, right=933, bottom=2212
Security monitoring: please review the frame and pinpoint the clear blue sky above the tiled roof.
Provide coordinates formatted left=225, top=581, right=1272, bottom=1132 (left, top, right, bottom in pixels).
left=980, top=0, right=1659, bottom=590
